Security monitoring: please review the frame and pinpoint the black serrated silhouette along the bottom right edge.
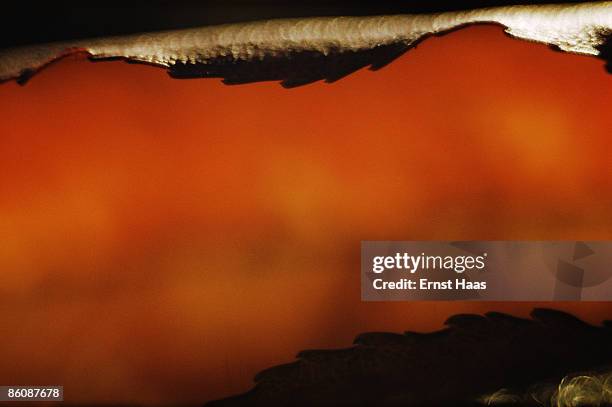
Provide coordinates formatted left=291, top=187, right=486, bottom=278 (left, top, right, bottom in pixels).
left=208, top=309, right=612, bottom=406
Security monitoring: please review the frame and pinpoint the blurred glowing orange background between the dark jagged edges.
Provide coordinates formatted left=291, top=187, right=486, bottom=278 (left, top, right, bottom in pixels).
left=0, top=26, right=612, bottom=403
